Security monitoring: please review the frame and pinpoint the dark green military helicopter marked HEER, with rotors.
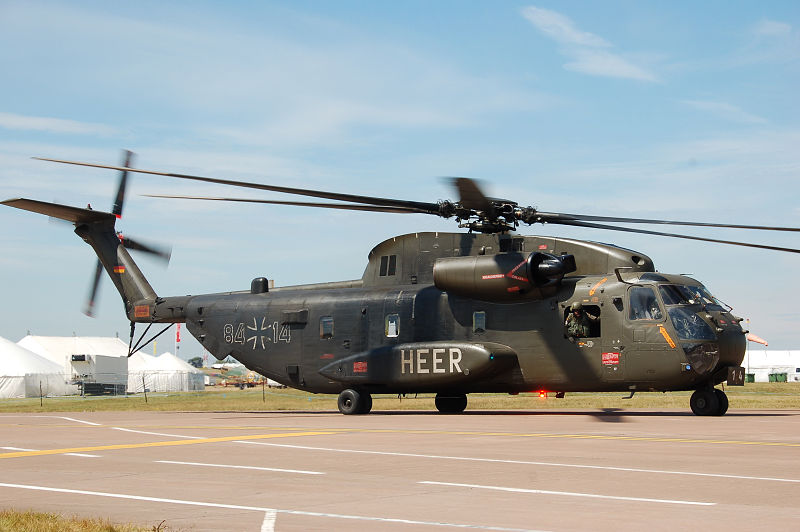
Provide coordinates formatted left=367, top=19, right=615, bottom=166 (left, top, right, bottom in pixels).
left=2, top=151, right=800, bottom=416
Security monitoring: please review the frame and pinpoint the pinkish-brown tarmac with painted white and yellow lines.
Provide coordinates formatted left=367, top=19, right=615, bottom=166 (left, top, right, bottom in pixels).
left=0, top=410, right=800, bottom=531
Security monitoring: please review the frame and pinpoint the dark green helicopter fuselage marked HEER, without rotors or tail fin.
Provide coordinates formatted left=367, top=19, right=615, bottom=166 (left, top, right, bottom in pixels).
left=153, top=233, right=745, bottom=394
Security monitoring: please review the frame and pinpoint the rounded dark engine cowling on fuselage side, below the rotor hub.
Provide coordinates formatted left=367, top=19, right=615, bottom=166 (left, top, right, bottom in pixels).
left=433, top=252, right=577, bottom=302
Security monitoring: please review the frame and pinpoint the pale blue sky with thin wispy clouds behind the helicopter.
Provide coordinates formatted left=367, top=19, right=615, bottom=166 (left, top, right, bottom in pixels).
left=0, top=0, right=800, bottom=358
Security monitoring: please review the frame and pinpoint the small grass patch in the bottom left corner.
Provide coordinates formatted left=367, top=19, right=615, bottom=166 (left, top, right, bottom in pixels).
left=0, top=510, right=167, bottom=532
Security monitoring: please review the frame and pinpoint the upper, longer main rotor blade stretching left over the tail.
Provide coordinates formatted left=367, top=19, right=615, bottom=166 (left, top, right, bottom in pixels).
left=34, top=157, right=443, bottom=216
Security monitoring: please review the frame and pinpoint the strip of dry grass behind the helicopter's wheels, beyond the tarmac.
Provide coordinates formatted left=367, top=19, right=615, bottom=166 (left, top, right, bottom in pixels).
left=0, top=382, right=800, bottom=412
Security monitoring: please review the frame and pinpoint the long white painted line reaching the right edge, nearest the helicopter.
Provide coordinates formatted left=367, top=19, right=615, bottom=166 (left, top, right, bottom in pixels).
left=234, top=440, right=800, bottom=483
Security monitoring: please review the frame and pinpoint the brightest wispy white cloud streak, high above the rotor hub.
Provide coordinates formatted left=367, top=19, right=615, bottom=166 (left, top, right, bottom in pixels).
left=522, top=6, right=658, bottom=82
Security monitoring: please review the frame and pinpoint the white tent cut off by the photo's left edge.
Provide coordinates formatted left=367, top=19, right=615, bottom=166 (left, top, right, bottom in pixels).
left=0, top=337, right=77, bottom=398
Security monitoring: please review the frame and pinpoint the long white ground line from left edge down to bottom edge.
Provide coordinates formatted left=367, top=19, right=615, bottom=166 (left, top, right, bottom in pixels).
left=0, top=482, right=542, bottom=532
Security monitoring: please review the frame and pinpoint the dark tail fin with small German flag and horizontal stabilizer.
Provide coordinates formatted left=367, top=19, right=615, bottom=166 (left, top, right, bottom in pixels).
left=0, top=198, right=157, bottom=318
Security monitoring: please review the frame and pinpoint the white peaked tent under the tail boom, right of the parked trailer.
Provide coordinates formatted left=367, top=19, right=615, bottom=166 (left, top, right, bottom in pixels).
left=128, top=352, right=205, bottom=392
